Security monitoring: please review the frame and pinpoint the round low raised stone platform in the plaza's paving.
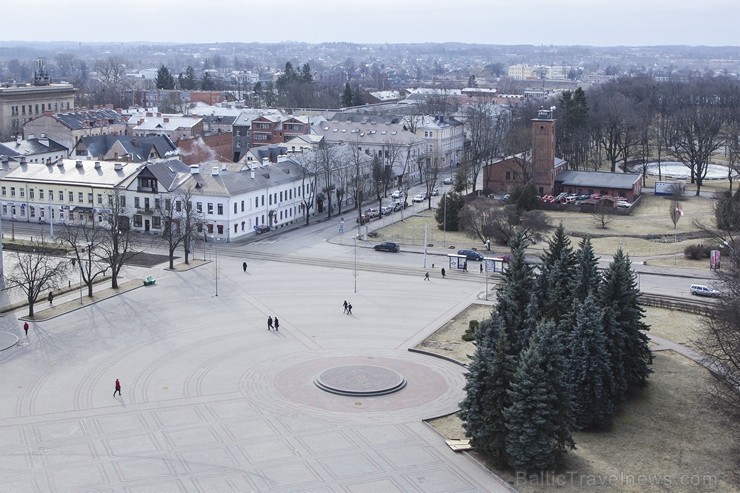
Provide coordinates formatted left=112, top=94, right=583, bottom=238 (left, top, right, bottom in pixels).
left=314, top=365, right=406, bottom=397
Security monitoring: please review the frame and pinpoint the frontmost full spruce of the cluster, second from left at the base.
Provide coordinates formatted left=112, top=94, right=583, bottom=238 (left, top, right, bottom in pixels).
left=504, top=321, right=575, bottom=473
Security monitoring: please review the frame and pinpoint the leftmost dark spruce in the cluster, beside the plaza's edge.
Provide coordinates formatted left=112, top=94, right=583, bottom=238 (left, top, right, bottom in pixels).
left=460, top=314, right=514, bottom=465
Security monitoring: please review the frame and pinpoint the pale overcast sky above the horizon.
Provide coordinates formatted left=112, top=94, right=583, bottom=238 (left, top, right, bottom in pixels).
left=5, top=0, right=740, bottom=46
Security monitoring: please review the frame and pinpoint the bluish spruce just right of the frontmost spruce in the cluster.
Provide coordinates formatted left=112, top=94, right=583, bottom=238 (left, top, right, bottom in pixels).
left=566, top=294, right=614, bottom=430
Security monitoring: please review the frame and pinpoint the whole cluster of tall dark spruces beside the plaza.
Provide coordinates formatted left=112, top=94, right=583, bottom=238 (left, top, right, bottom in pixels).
left=460, top=225, right=652, bottom=473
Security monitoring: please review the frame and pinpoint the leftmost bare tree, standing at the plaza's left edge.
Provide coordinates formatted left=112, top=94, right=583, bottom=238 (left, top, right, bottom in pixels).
left=5, top=236, right=69, bottom=317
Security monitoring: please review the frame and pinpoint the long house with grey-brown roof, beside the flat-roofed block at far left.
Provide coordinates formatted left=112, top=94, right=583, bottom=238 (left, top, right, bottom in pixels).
left=23, top=108, right=126, bottom=149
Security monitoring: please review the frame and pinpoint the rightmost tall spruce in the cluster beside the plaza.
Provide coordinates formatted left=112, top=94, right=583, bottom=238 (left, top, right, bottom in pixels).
left=598, top=248, right=652, bottom=390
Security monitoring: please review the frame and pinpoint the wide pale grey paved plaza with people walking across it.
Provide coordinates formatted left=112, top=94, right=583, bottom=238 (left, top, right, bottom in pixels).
left=0, top=249, right=506, bottom=493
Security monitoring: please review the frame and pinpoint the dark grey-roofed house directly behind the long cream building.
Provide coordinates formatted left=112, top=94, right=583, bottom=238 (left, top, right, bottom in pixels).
left=74, top=135, right=178, bottom=163
